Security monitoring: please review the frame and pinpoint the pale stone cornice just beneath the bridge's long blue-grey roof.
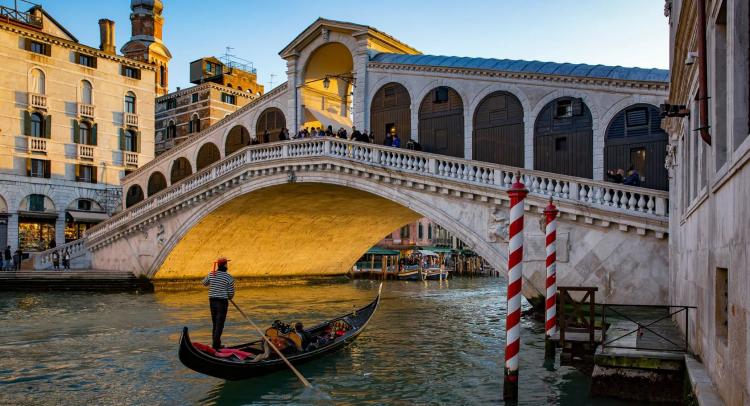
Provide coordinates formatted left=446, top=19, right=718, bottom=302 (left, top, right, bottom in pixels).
left=368, top=61, right=669, bottom=91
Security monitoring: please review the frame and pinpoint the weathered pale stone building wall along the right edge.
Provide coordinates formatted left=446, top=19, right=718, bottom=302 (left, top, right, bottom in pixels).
left=664, top=0, right=750, bottom=405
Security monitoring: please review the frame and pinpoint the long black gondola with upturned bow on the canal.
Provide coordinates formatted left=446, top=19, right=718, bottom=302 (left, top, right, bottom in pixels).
left=179, top=292, right=380, bottom=381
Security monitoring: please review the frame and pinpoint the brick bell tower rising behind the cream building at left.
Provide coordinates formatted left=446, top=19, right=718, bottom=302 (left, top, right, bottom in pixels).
left=120, top=0, right=172, bottom=97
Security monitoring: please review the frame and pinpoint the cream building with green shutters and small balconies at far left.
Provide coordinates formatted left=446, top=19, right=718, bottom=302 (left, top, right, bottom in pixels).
left=0, top=2, right=156, bottom=251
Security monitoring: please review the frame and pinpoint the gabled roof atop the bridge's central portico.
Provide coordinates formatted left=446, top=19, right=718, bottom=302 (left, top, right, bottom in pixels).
left=279, top=17, right=421, bottom=59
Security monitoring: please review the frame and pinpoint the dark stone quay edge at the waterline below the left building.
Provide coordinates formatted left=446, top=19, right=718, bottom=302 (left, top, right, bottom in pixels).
left=0, top=269, right=154, bottom=292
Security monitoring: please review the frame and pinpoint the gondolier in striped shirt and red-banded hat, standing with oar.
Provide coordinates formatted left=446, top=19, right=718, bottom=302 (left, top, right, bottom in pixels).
left=203, top=257, right=234, bottom=350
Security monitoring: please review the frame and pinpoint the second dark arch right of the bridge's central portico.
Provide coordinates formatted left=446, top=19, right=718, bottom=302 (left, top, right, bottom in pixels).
left=420, top=86, right=464, bottom=158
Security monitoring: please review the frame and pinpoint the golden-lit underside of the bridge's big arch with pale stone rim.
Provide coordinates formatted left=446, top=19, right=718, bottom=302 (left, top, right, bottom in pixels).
left=149, top=178, right=506, bottom=279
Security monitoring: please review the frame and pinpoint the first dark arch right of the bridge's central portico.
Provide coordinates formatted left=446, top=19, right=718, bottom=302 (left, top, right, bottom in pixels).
left=369, top=82, right=411, bottom=144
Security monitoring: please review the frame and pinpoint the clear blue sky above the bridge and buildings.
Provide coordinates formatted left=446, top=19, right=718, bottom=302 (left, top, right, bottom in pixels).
left=36, top=0, right=669, bottom=91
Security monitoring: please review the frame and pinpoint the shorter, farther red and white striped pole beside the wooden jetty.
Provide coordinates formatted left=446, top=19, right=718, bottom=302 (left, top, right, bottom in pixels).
left=544, top=198, right=559, bottom=357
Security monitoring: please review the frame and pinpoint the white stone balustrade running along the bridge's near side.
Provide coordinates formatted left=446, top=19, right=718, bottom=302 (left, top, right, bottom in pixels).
left=86, top=138, right=669, bottom=247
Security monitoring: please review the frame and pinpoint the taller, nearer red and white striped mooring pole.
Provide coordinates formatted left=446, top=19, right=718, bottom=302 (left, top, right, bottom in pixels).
left=503, top=173, right=529, bottom=400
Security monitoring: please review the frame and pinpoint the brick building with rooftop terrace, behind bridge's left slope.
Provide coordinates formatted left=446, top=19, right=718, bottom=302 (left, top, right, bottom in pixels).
left=156, top=57, right=263, bottom=155
